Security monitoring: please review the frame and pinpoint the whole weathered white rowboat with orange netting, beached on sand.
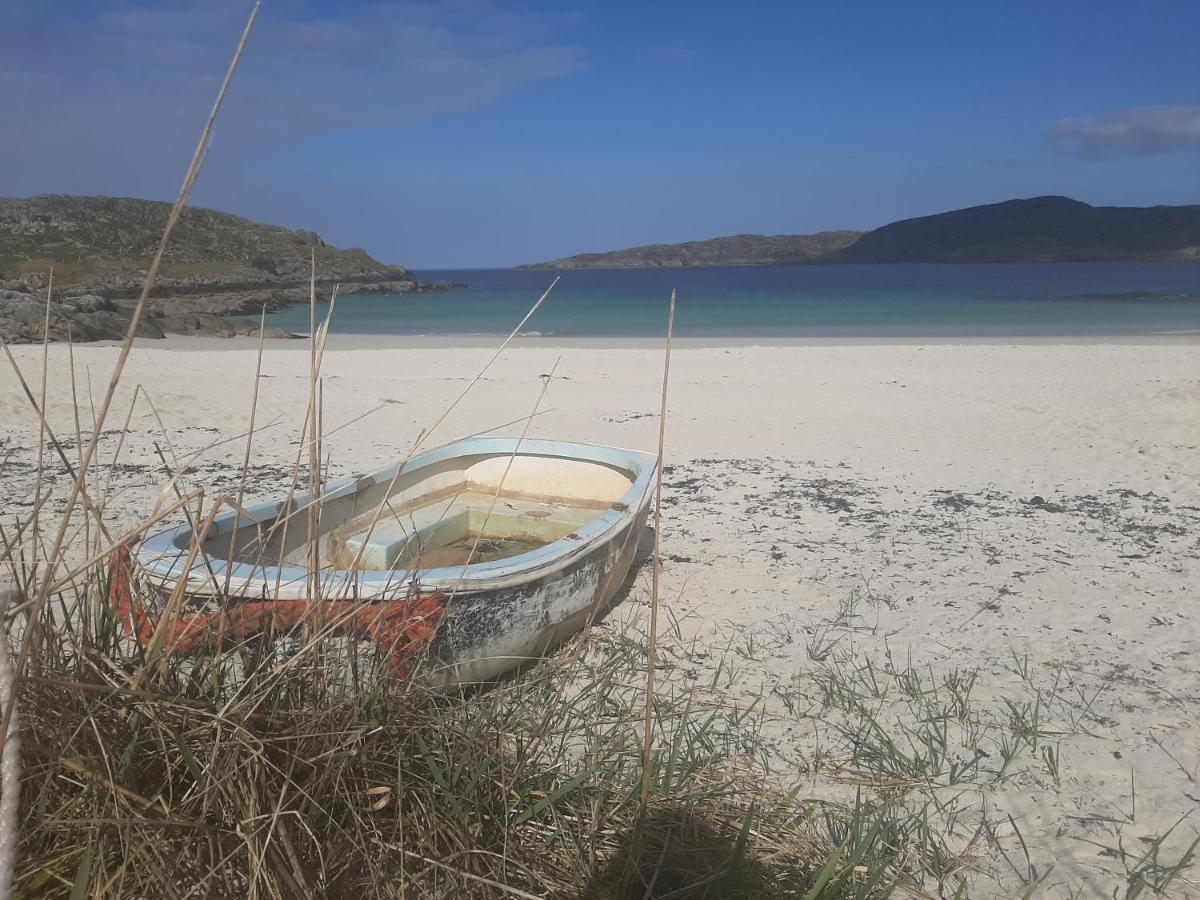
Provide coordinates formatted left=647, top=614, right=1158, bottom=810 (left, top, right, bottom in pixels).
left=121, top=438, right=656, bottom=686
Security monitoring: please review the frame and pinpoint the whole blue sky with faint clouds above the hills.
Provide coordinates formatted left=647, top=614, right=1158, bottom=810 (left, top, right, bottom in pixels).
left=0, top=0, right=1200, bottom=269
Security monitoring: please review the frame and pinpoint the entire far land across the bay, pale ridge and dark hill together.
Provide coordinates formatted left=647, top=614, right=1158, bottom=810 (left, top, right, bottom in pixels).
left=521, top=197, right=1200, bottom=269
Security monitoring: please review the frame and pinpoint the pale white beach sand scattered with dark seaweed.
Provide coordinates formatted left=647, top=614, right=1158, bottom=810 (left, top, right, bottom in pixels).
left=0, top=336, right=1200, bottom=896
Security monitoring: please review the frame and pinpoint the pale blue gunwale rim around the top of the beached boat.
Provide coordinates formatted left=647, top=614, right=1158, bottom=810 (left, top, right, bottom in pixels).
left=133, top=437, right=658, bottom=599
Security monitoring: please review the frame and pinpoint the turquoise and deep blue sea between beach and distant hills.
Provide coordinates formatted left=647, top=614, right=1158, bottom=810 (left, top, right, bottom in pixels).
left=260, top=263, right=1200, bottom=337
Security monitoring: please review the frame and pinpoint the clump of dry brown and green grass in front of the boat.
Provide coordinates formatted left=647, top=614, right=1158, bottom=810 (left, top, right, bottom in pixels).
left=4, top=556, right=899, bottom=898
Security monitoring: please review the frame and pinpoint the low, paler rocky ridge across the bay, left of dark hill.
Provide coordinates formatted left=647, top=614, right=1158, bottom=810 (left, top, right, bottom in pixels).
left=517, top=232, right=862, bottom=269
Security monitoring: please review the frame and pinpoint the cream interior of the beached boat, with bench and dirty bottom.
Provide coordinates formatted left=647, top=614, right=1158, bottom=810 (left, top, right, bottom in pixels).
left=204, top=452, right=636, bottom=571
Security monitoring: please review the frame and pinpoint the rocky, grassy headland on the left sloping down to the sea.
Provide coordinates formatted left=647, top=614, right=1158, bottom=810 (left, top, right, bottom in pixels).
left=0, top=194, right=463, bottom=340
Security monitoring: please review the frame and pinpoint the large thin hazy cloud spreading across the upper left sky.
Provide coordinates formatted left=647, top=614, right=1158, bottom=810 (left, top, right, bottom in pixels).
left=0, top=0, right=586, bottom=194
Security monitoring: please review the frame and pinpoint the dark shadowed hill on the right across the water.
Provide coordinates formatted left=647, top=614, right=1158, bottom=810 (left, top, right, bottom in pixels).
left=829, top=197, right=1200, bottom=263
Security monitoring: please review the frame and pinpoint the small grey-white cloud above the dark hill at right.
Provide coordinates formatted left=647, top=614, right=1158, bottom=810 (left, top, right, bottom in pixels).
left=1045, top=107, right=1200, bottom=160
